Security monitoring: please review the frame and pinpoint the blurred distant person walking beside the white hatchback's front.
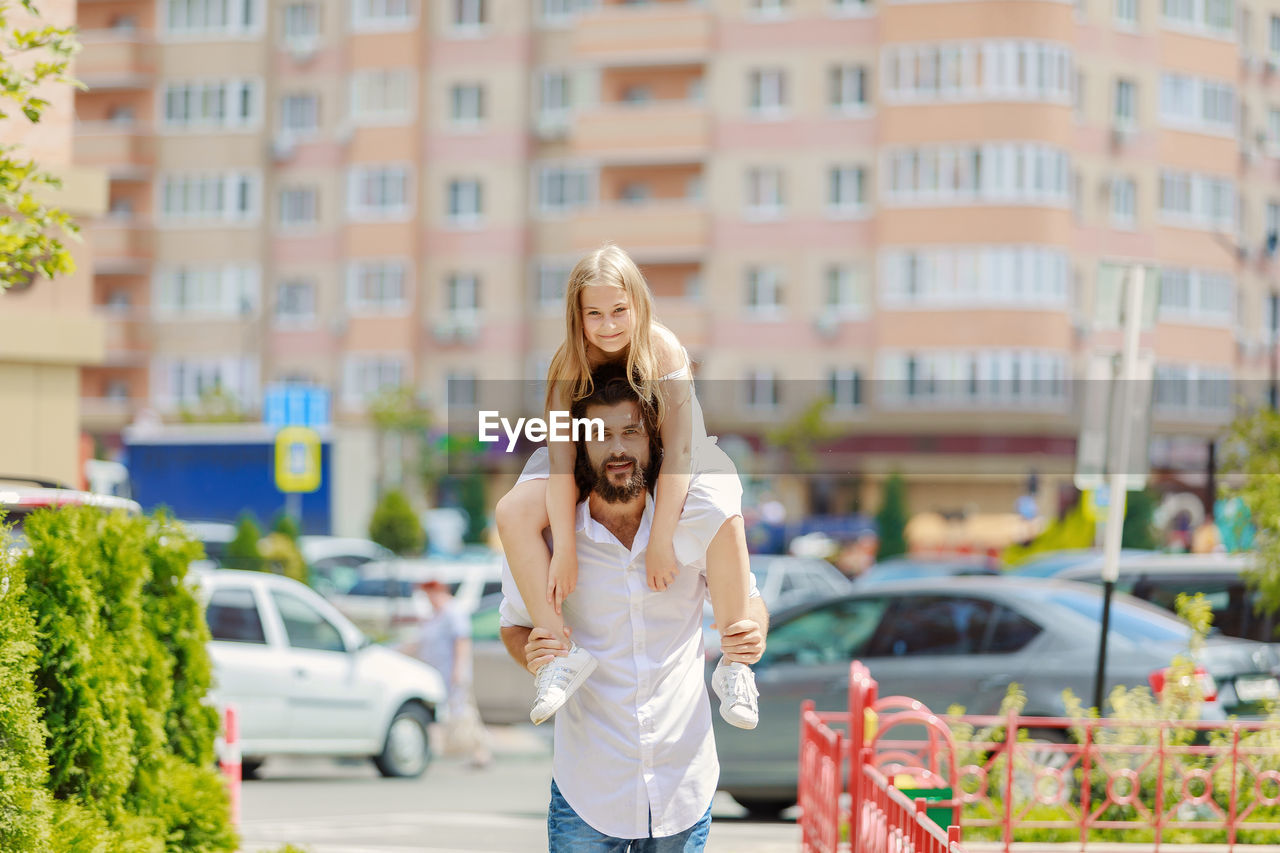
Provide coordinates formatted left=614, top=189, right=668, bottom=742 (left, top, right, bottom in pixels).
left=411, top=580, right=493, bottom=767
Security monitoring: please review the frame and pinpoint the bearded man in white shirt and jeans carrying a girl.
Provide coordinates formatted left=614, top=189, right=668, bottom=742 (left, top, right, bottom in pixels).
left=500, top=368, right=768, bottom=853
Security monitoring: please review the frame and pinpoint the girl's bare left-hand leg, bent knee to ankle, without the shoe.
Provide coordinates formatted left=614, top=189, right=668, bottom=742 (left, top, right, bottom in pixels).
left=494, top=480, right=564, bottom=637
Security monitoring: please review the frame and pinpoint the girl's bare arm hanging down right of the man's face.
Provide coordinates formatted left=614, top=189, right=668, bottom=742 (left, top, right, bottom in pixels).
left=645, top=352, right=694, bottom=592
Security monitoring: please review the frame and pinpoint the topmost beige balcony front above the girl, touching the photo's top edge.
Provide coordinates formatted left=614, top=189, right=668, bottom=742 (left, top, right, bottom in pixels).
left=573, top=3, right=713, bottom=65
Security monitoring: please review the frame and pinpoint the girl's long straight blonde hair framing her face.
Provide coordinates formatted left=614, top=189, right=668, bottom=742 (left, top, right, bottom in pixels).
left=547, top=243, right=666, bottom=424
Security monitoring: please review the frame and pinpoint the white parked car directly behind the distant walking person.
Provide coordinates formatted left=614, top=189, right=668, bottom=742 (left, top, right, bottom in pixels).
left=329, top=552, right=502, bottom=642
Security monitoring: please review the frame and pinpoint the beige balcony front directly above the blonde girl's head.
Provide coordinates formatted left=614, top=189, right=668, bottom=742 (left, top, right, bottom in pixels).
left=570, top=199, right=710, bottom=263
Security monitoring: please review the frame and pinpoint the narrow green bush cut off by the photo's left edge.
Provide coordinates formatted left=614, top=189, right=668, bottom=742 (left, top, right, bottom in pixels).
left=0, top=533, right=51, bottom=850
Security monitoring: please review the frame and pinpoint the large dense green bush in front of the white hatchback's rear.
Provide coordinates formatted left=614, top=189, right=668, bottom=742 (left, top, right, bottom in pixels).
left=13, top=507, right=237, bottom=853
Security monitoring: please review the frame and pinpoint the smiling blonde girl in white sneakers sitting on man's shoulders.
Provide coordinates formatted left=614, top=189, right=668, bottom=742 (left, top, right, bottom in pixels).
left=495, top=245, right=758, bottom=729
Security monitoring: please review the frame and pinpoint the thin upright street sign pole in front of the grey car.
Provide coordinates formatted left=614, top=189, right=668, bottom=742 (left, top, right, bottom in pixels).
left=1093, top=265, right=1147, bottom=716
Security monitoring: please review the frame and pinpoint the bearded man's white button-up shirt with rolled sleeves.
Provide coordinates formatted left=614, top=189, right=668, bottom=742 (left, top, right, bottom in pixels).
left=499, top=496, right=759, bottom=838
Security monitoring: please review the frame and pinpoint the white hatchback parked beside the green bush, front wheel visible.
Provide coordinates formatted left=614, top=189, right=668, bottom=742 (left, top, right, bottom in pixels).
left=193, top=569, right=445, bottom=777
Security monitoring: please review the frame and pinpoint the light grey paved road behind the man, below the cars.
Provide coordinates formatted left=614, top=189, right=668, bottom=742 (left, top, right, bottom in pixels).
left=242, top=726, right=800, bottom=853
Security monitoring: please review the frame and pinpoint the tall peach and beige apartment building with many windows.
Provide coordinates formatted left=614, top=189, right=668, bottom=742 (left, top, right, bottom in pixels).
left=77, top=0, right=1280, bottom=511
